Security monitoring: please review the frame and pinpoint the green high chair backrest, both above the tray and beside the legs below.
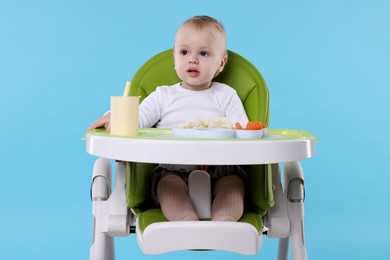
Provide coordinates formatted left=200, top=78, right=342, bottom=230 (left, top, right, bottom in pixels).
left=126, top=49, right=274, bottom=216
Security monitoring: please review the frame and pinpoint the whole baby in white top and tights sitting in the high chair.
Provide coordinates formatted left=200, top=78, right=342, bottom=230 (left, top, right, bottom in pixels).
left=88, top=16, right=248, bottom=221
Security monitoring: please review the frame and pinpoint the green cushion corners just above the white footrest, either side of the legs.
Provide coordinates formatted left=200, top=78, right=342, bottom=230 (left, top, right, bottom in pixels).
left=138, top=208, right=263, bottom=234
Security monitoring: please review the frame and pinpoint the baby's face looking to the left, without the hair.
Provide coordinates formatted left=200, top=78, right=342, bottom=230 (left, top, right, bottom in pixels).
left=174, top=25, right=227, bottom=90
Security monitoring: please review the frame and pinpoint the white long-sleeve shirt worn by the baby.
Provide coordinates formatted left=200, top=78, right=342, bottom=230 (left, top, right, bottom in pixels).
left=139, top=82, right=248, bottom=128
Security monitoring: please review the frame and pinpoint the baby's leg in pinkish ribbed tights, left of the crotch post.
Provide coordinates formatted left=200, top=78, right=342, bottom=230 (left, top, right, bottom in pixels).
left=157, top=174, right=199, bottom=221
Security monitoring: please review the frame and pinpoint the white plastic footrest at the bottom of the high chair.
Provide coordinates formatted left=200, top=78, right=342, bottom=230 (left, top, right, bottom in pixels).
left=137, top=221, right=262, bottom=254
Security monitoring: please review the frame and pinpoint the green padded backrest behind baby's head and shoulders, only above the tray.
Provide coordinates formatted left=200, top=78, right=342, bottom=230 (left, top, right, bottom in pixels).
left=130, top=49, right=269, bottom=125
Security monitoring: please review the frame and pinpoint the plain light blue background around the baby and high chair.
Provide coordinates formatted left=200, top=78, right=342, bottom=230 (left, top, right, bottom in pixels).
left=0, top=0, right=390, bottom=260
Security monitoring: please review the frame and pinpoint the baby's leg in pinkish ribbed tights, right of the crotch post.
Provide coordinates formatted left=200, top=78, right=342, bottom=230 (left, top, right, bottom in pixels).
left=211, top=175, right=245, bottom=221
